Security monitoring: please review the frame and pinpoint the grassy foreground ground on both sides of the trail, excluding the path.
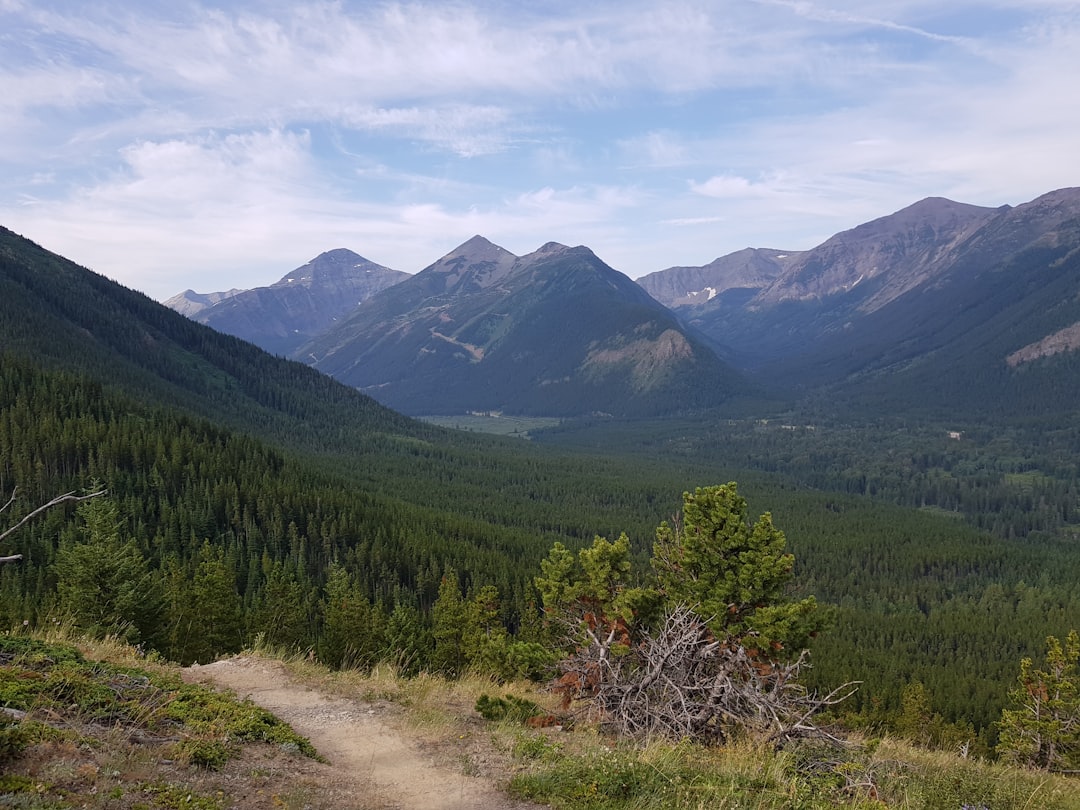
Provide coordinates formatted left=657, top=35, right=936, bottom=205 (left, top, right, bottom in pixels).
left=0, top=636, right=1080, bottom=810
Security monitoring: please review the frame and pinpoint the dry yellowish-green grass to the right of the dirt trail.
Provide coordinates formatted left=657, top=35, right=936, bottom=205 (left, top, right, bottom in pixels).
left=259, top=661, right=1080, bottom=810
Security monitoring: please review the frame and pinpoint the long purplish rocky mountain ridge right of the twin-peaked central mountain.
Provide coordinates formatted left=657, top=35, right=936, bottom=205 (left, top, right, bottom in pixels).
left=649, top=188, right=1080, bottom=414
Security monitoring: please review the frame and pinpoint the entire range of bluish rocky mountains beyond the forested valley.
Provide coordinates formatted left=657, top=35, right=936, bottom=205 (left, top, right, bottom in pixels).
left=170, top=188, right=1080, bottom=416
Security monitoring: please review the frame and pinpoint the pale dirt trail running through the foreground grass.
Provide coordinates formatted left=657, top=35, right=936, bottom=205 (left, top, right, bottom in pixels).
left=184, top=657, right=536, bottom=810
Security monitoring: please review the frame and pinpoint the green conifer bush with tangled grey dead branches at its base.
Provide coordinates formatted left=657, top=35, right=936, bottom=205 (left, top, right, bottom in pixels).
left=537, top=484, right=855, bottom=744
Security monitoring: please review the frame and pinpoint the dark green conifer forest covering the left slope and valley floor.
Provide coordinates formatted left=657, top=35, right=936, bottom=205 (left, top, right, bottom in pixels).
left=0, top=225, right=1080, bottom=752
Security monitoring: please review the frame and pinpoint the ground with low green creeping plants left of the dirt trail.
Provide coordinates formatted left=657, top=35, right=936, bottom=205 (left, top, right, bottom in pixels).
left=0, top=632, right=332, bottom=810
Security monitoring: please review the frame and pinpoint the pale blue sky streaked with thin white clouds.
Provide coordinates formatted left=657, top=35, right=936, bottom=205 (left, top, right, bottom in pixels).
left=0, top=0, right=1080, bottom=300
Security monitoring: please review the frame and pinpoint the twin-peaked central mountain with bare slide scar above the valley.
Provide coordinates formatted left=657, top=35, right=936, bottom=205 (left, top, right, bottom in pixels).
left=294, top=237, right=740, bottom=416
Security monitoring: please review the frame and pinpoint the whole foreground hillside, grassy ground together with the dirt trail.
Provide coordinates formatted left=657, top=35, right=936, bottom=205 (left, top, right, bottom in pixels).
left=8, top=637, right=1080, bottom=810
